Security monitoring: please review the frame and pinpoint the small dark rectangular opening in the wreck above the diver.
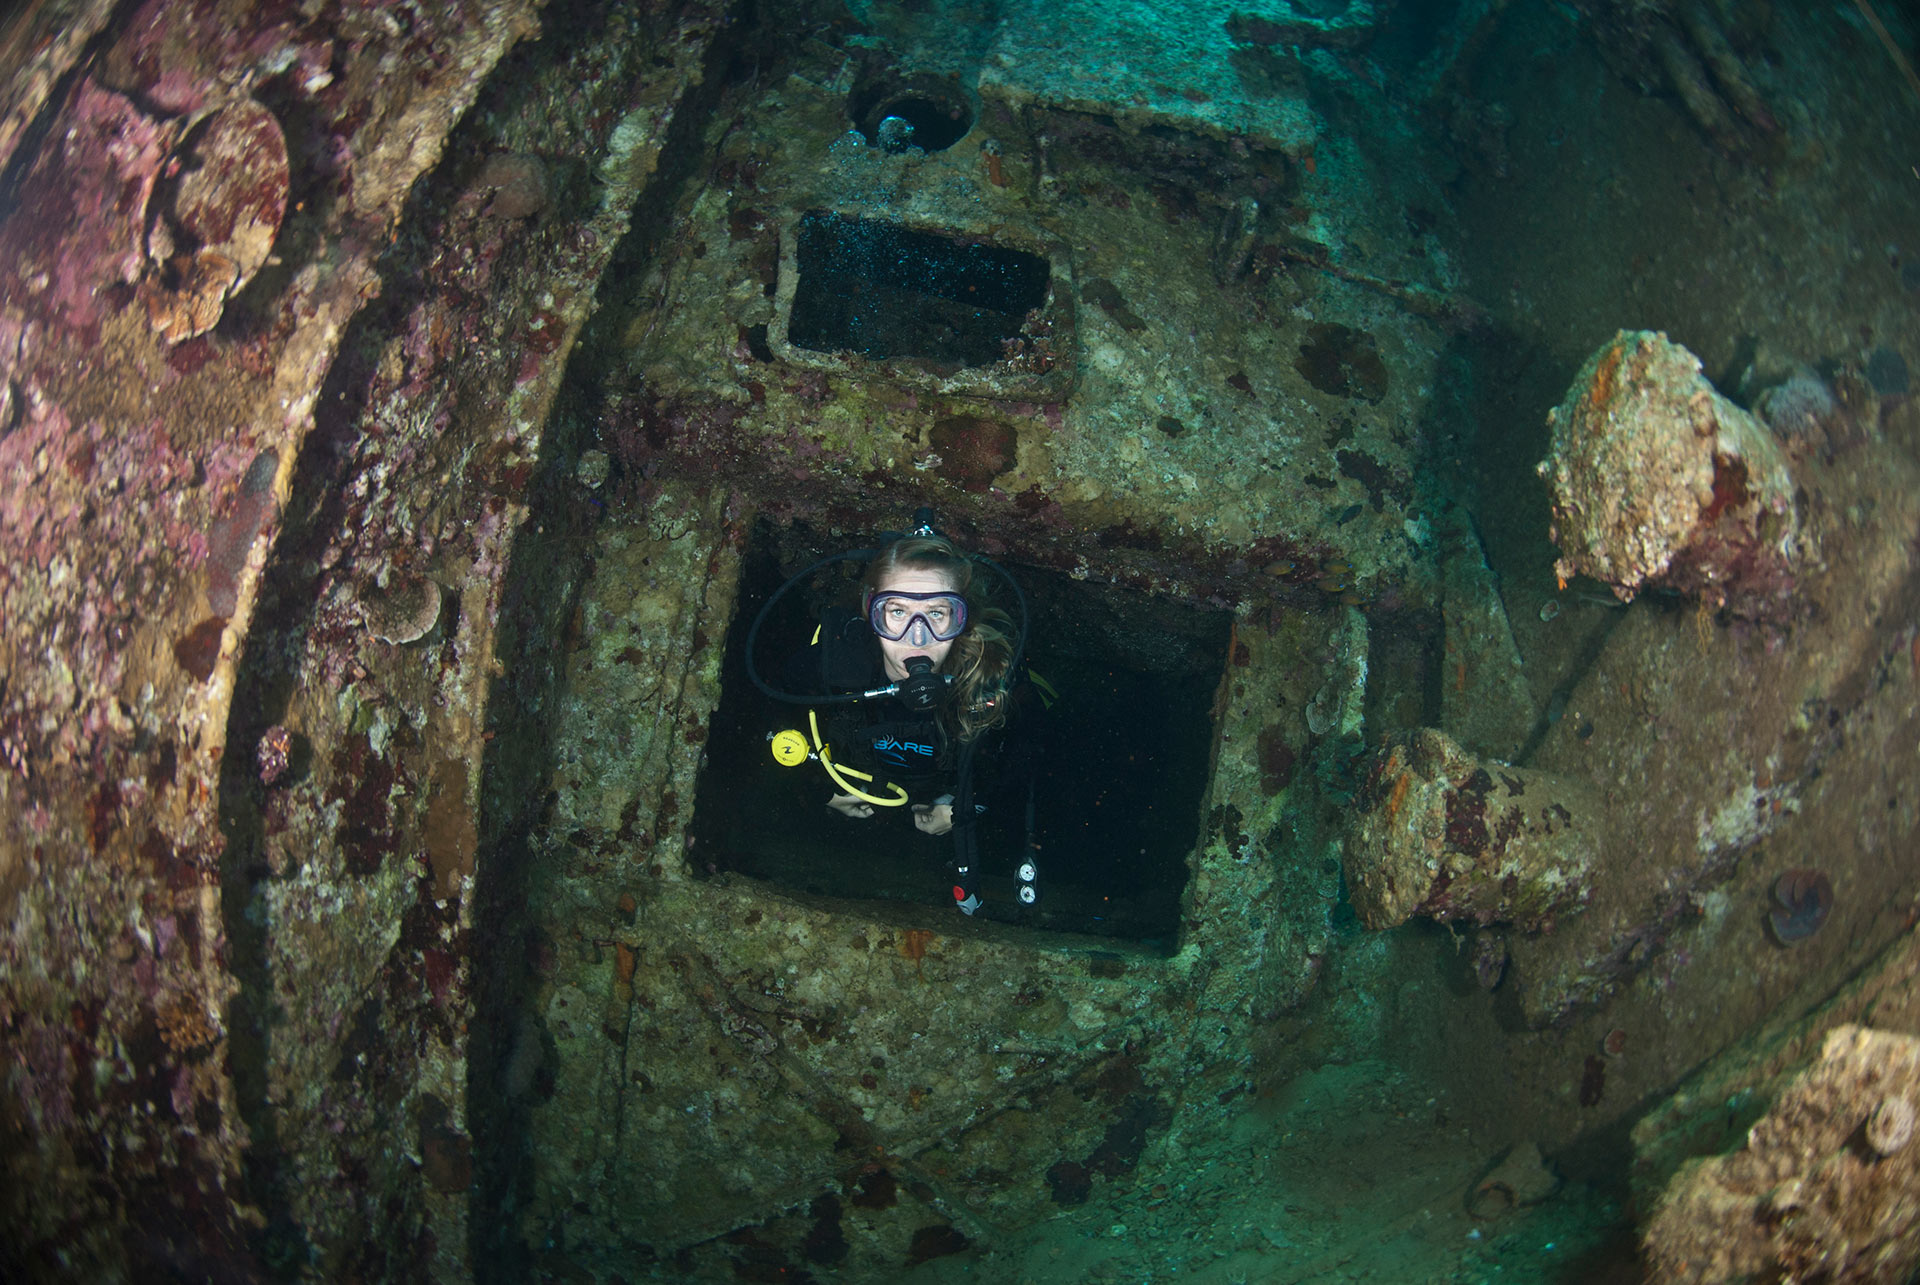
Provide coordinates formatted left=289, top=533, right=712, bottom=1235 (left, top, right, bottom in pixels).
left=787, top=211, right=1050, bottom=367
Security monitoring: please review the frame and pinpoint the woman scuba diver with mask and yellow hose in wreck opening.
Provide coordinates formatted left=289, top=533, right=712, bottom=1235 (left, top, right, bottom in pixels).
left=747, top=509, right=1037, bottom=914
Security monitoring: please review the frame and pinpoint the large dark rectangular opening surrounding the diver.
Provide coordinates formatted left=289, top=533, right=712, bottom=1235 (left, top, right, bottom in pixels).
left=691, top=526, right=1231, bottom=949
